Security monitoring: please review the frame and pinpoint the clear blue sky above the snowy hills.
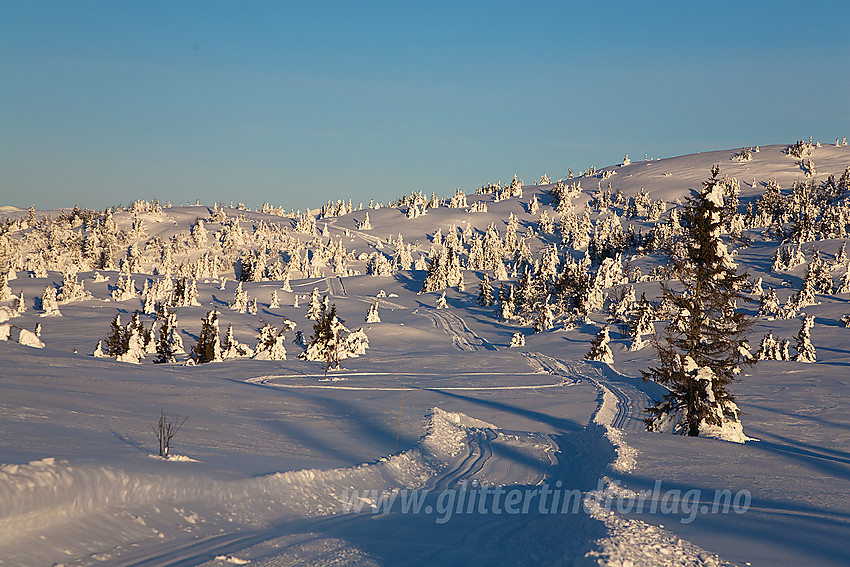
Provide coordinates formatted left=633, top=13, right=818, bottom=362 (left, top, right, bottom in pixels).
left=0, top=0, right=850, bottom=213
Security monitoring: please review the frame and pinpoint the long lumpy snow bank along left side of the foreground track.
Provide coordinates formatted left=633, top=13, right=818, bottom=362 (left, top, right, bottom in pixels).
left=0, top=408, right=491, bottom=556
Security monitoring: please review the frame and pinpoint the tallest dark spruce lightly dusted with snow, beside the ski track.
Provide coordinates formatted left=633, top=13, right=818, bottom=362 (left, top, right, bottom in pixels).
left=642, top=165, right=755, bottom=442
